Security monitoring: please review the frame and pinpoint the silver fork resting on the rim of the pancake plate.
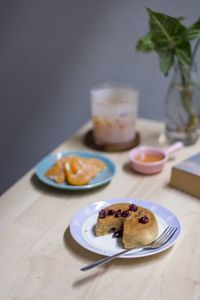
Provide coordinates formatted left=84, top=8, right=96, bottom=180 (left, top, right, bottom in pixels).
left=81, top=226, right=177, bottom=271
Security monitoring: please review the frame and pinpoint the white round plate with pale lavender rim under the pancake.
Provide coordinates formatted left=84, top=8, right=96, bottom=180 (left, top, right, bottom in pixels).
left=70, top=198, right=181, bottom=258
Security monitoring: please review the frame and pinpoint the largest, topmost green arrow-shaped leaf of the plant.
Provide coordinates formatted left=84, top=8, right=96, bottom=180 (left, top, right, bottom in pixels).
left=147, top=8, right=192, bottom=71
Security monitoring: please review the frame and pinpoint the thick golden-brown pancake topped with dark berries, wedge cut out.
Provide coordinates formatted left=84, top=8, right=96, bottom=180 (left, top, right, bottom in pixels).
left=95, top=203, right=158, bottom=249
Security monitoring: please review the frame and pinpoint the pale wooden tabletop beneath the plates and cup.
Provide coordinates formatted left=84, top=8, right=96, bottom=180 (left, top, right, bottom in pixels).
left=0, top=120, right=200, bottom=300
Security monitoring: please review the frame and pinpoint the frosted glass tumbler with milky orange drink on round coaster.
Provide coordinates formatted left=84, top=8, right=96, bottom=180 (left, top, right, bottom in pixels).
left=91, top=84, right=138, bottom=147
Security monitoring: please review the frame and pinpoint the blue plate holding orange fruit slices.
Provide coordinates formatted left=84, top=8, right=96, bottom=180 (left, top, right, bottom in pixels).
left=35, top=151, right=116, bottom=191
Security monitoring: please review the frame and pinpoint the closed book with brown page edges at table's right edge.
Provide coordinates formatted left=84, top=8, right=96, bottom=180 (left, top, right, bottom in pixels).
left=170, top=152, right=200, bottom=198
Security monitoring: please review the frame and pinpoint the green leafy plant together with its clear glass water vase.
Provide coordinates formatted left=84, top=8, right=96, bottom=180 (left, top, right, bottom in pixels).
left=136, top=8, right=200, bottom=144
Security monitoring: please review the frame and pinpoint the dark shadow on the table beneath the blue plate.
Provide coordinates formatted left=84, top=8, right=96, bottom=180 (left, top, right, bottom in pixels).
left=31, top=174, right=110, bottom=198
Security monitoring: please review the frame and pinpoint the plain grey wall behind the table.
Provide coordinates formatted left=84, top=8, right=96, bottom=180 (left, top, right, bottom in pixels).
left=0, top=0, right=200, bottom=192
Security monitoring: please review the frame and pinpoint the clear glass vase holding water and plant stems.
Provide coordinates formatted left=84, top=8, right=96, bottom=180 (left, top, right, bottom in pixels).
left=164, top=65, right=200, bottom=145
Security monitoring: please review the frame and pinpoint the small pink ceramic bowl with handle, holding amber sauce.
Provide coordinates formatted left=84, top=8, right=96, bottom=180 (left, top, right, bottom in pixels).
left=129, top=142, right=183, bottom=174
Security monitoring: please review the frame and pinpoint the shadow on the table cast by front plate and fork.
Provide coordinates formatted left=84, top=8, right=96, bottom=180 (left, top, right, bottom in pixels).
left=63, top=227, right=170, bottom=287
